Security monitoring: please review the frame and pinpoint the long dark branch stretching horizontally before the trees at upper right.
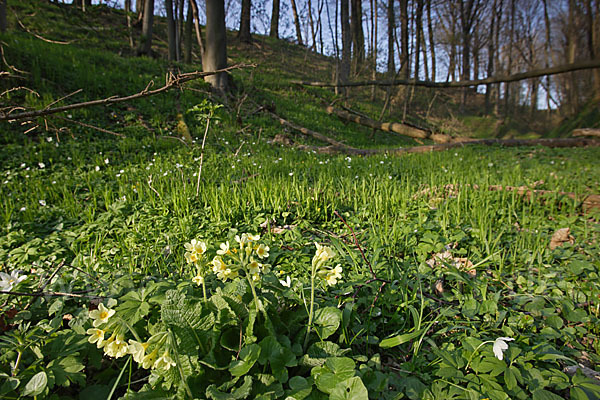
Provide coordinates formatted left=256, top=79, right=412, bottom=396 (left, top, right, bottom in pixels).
left=290, top=59, right=600, bottom=88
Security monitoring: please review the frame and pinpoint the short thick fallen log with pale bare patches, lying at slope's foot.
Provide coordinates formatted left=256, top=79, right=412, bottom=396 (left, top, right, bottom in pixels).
left=326, top=106, right=463, bottom=143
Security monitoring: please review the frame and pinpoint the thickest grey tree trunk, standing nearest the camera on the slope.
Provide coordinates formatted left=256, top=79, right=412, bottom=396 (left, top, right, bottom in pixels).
left=202, top=0, right=229, bottom=95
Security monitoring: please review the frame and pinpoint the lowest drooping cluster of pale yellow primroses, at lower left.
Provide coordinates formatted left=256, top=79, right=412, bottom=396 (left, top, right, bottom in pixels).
left=87, top=303, right=175, bottom=371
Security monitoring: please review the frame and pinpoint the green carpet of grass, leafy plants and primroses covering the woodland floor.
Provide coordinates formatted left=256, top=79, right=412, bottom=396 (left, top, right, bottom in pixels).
left=0, top=1, right=600, bottom=399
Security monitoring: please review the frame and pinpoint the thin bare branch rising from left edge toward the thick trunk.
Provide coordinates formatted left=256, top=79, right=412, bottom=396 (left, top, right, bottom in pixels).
left=0, top=64, right=254, bottom=122
